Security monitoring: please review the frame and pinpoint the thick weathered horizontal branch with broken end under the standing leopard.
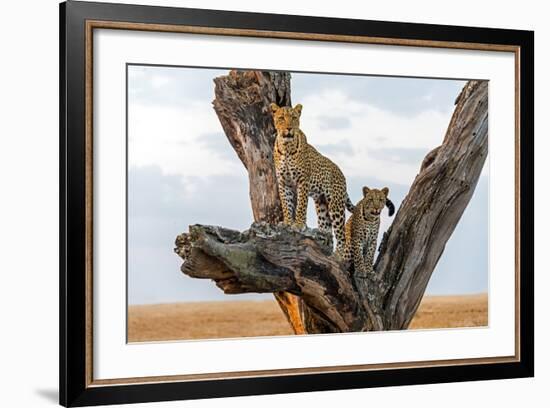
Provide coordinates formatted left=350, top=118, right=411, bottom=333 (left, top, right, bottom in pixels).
left=182, top=223, right=365, bottom=332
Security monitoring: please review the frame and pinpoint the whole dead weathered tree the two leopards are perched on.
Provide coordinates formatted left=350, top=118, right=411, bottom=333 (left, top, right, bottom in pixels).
left=176, top=71, right=488, bottom=333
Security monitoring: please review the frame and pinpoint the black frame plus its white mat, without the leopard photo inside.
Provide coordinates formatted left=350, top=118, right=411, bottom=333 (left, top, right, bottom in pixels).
left=60, top=1, right=534, bottom=406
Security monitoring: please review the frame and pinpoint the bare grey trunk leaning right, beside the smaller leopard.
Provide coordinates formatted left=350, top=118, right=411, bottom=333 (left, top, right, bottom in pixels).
left=378, top=81, right=489, bottom=329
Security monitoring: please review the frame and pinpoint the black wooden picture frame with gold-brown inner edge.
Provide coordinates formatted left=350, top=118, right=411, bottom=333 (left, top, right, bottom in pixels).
left=60, top=1, right=534, bottom=406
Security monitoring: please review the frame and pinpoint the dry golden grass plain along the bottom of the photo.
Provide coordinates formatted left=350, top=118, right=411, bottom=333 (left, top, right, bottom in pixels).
left=128, top=294, right=488, bottom=342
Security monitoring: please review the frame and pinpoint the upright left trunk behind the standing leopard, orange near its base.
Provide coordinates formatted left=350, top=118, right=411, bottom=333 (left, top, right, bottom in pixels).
left=213, top=71, right=306, bottom=334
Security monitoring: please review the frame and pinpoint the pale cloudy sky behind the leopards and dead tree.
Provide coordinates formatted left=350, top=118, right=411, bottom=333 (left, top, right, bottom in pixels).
left=128, top=65, right=489, bottom=304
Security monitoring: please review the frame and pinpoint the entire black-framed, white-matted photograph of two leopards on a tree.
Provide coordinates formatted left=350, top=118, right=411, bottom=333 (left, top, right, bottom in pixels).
left=60, top=1, right=534, bottom=406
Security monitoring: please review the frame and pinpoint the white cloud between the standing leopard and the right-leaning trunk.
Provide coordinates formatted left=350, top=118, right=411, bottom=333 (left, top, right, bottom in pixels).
left=301, top=89, right=452, bottom=185
